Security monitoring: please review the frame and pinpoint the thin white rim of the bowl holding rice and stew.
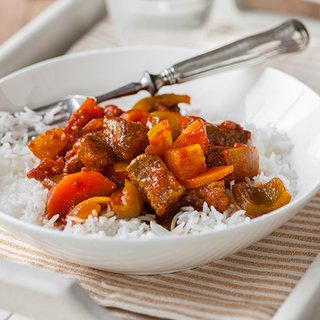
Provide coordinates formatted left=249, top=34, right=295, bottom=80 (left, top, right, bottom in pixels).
left=0, top=46, right=320, bottom=244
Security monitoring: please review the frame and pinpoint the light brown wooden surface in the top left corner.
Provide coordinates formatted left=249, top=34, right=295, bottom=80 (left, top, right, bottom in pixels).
left=0, top=0, right=54, bottom=44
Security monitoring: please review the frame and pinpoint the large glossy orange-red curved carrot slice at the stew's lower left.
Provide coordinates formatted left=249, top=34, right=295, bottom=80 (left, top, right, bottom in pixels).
left=46, top=171, right=116, bottom=219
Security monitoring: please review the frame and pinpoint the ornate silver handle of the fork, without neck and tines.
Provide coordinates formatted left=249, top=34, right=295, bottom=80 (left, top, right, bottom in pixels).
left=156, top=19, right=309, bottom=85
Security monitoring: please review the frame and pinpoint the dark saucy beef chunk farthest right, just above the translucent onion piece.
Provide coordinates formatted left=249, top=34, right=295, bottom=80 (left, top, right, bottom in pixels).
left=206, top=121, right=251, bottom=147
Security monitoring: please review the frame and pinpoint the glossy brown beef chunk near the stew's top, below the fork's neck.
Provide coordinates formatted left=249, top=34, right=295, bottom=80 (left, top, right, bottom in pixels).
left=104, top=117, right=148, bottom=160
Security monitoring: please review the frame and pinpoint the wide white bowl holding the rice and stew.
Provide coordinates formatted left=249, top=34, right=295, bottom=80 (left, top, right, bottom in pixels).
left=0, top=48, right=320, bottom=274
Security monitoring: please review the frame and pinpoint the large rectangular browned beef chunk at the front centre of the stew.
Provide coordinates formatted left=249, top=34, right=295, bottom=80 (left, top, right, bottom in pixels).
left=127, top=154, right=185, bottom=216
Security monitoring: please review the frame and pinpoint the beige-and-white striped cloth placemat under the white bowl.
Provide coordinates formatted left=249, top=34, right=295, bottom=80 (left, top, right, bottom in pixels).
left=0, top=20, right=320, bottom=320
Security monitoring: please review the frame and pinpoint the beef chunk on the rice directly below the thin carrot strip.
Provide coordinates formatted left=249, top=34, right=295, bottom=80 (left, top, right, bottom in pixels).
left=183, top=181, right=229, bottom=212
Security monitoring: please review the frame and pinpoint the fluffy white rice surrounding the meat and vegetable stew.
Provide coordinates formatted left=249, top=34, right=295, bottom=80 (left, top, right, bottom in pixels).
left=0, top=108, right=296, bottom=238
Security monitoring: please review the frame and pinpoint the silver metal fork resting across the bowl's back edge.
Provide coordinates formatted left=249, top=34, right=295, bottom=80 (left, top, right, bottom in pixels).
left=34, top=19, right=309, bottom=125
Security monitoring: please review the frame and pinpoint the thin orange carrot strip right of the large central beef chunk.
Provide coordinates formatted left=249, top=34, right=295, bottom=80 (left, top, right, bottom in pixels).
left=183, top=165, right=233, bottom=189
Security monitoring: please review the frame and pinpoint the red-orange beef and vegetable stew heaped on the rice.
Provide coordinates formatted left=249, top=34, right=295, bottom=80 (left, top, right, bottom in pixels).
left=28, top=94, right=291, bottom=227
